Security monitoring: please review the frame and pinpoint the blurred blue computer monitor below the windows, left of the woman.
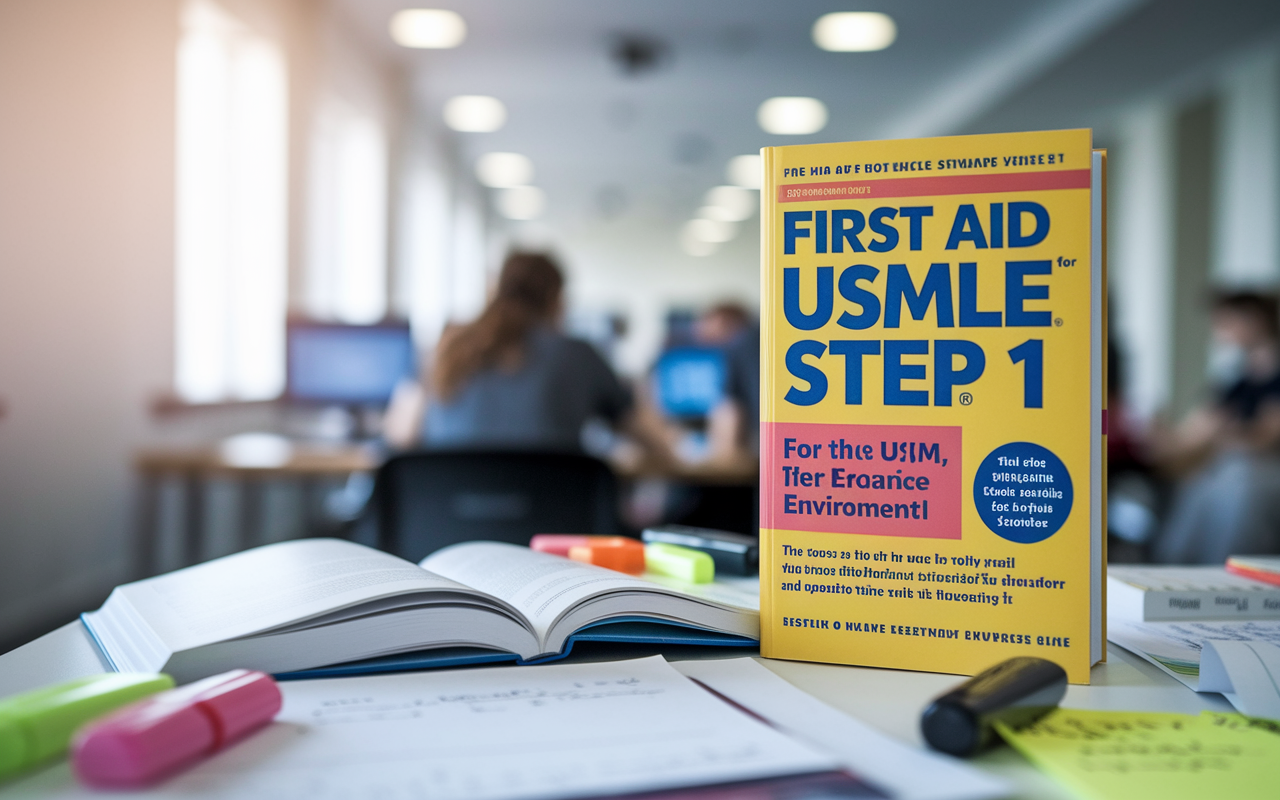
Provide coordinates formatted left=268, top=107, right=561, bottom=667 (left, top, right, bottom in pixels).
left=285, top=321, right=417, bottom=406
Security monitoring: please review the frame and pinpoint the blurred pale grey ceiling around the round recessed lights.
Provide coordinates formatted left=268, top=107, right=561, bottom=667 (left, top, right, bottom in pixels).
left=325, top=0, right=1167, bottom=236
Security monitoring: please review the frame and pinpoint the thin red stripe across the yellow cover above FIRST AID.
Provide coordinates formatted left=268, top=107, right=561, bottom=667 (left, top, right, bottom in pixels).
left=778, top=169, right=1091, bottom=202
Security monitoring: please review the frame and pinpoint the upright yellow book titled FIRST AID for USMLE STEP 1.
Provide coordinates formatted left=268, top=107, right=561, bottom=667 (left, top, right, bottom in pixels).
left=760, top=131, right=1106, bottom=684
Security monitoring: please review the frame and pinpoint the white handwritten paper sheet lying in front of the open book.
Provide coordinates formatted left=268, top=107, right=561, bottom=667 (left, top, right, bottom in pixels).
left=6, top=657, right=834, bottom=800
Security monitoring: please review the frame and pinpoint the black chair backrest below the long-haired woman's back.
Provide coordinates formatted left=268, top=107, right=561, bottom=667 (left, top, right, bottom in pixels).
left=374, top=451, right=617, bottom=561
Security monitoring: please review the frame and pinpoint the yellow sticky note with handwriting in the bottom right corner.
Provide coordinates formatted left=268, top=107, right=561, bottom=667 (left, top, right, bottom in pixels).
left=996, top=709, right=1280, bottom=800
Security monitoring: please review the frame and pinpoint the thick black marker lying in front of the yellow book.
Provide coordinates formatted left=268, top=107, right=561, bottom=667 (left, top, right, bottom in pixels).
left=920, top=655, right=1066, bottom=758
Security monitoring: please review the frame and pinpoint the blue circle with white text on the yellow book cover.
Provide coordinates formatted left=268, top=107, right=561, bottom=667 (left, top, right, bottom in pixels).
left=973, top=442, right=1073, bottom=544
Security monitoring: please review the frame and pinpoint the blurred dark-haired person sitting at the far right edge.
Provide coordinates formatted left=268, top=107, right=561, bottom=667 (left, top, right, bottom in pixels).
left=1152, top=292, right=1280, bottom=564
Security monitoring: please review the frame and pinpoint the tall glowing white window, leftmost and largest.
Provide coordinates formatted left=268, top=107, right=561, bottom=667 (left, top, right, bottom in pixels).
left=175, top=0, right=288, bottom=402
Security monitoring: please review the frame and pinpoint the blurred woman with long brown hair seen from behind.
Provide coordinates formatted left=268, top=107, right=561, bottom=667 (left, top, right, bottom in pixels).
left=422, top=253, right=632, bottom=451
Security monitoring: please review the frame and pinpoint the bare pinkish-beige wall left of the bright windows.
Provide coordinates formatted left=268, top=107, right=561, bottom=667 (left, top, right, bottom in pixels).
left=0, top=0, right=178, bottom=636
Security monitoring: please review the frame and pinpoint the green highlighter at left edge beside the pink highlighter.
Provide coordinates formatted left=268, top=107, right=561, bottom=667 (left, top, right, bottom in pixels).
left=0, top=672, right=173, bottom=780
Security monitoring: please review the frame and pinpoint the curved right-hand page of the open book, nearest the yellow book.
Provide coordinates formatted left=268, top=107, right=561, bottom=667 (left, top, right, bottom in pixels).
left=421, top=541, right=750, bottom=652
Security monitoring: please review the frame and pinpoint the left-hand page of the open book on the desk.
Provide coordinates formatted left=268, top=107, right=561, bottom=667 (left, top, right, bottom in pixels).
left=96, top=539, right=477, bottom=652
